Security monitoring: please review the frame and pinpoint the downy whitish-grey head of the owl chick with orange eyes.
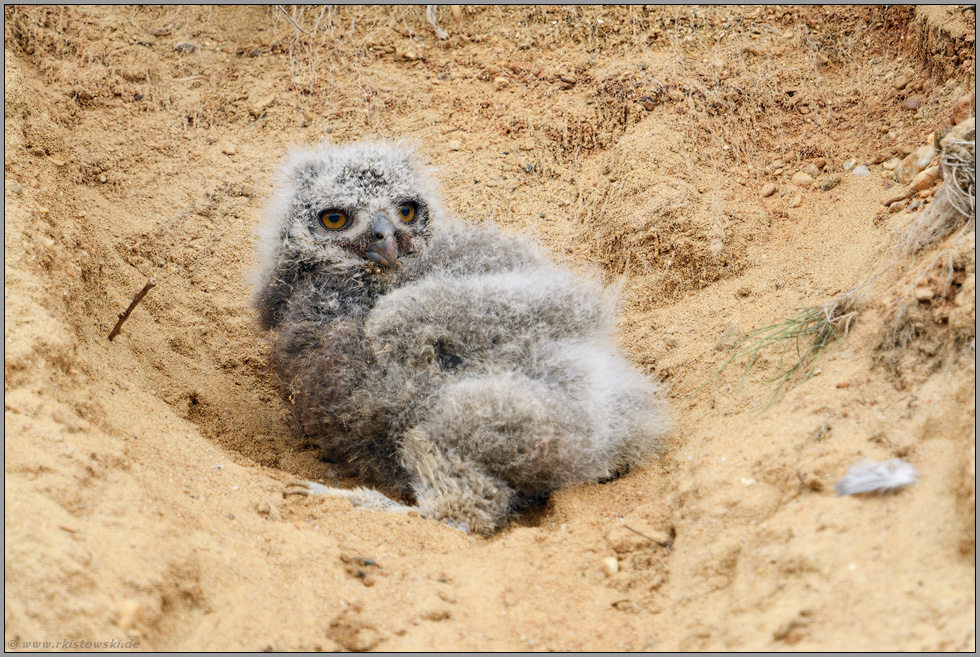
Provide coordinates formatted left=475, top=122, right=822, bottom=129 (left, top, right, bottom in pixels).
left=257, top=141, right=442, bottom=285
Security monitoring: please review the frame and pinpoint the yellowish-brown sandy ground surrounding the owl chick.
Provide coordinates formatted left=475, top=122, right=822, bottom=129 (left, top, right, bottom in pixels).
left=4, top=6, right=976, bottom=651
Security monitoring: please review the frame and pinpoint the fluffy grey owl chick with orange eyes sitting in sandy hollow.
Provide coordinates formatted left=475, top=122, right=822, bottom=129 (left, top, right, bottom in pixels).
left=254, top=142, right=668, bottom=535
